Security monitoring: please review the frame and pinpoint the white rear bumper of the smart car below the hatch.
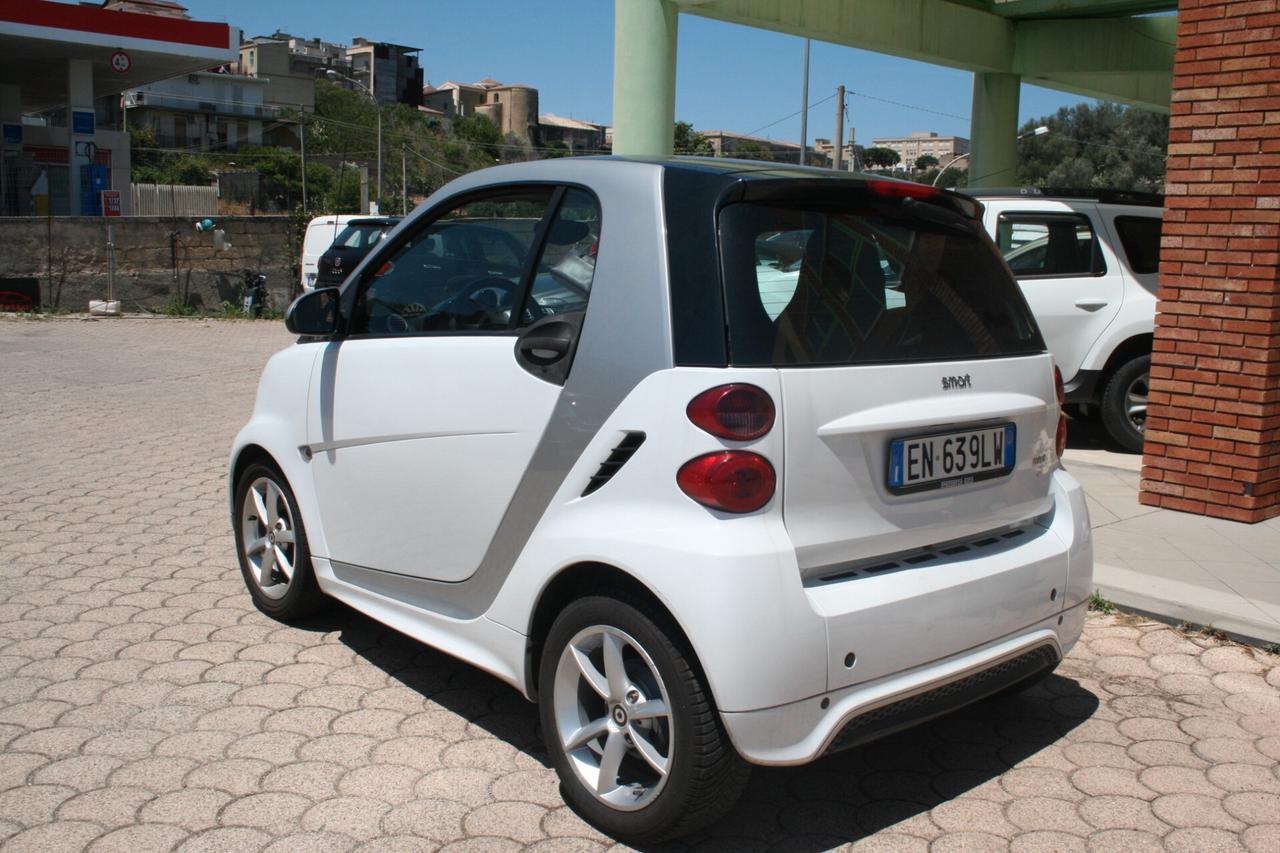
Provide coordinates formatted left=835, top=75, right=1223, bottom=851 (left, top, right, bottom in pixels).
left=721, top=470, right=1093, bottom=765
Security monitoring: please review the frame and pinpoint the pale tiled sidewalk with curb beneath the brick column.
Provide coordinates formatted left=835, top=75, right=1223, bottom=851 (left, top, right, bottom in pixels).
left=1065, top=448, right=1280, bottom=643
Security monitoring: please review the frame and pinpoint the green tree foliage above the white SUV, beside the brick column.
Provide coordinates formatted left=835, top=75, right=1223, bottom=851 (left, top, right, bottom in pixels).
left=1018, top=104, right=1169, bottom=192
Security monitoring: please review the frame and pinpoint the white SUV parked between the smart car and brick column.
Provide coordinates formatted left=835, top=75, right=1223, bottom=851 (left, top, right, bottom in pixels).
left=972, top=188, right=1164, bottom=453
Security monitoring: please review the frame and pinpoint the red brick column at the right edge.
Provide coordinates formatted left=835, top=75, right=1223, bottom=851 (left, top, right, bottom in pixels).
left=1139, top=0, right=1280, bottom=521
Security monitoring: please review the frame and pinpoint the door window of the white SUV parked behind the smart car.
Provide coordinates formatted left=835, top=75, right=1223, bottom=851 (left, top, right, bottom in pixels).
left=996, top=213, right=1107, bottom=278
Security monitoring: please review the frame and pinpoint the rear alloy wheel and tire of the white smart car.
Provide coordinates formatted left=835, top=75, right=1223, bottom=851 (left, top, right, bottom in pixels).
left=539, top=596, right=750, bottom=841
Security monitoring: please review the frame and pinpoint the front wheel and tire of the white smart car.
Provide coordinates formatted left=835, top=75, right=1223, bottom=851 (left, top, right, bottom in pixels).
left=233, top=462, right=325, bottom=621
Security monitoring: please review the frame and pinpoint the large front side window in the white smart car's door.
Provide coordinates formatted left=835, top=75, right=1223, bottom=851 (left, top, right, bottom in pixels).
left=351, top=187, right=553, bottom=334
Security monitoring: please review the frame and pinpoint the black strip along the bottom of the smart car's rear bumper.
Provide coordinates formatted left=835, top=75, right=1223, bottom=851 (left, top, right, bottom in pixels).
left=827, top=646, right=1059, bottom=754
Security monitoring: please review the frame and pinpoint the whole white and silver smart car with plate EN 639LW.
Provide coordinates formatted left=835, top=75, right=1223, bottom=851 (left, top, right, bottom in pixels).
left=229, top=158, right=1092, bottom=840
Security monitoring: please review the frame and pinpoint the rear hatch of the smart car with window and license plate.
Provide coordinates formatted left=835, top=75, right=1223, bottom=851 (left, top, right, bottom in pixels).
left=719, top=181, right=1059, bottom=579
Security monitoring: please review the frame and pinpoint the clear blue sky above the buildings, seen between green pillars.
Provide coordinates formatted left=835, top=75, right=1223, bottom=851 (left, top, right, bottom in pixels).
left=183, top=0, right=1085, bottom=142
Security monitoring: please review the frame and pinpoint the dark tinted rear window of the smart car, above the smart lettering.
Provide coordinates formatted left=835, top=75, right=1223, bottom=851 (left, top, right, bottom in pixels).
left=719, top=199, right=1044, bottom=366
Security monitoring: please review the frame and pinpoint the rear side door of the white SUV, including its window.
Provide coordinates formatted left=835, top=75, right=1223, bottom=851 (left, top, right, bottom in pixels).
left=988, top=202, right=1124, bottom=383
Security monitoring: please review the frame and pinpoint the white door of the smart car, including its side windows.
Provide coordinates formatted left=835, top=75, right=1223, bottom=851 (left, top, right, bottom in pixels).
left=307, top=187, right=599, bottom=581
